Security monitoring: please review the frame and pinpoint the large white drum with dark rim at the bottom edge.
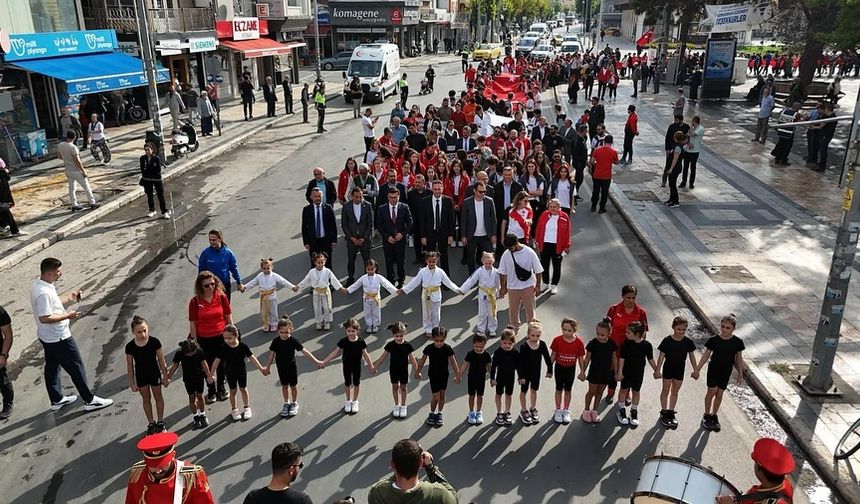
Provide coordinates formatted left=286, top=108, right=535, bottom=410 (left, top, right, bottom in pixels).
left=630, top=455, right=740, bottom=504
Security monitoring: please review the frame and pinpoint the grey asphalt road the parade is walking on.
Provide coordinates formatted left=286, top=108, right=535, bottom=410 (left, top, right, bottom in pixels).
left=0, top=53, right=802, bottom=503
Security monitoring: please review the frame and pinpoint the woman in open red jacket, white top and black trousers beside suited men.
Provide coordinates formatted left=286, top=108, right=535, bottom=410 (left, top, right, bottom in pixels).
left=534, top=198, right=570, bottom=294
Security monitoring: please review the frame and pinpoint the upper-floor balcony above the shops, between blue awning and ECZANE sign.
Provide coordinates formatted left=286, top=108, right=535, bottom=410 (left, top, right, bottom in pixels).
left=84, top=7, right=215, bottom=33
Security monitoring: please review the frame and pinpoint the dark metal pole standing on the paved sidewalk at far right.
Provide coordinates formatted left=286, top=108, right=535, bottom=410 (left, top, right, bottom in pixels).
left=798, top=95, right=860, bottom=395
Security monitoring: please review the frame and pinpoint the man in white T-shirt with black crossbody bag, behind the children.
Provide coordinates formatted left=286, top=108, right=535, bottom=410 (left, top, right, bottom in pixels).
left=499, top=234, right=543, bottom=329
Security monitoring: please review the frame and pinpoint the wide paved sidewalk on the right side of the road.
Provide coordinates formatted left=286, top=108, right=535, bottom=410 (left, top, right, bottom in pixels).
left=559, top=81, right=860, bottom=502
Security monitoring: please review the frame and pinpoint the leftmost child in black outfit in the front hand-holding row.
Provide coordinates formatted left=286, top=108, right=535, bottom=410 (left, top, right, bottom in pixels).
left=125, top=315, right=170, bottom=435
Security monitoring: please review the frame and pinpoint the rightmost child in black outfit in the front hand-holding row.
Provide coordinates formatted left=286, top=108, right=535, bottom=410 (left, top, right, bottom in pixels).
left=693, top=313, right=745, bottom=432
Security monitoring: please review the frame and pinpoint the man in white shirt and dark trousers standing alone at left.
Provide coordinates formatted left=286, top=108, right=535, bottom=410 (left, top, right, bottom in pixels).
left=30, top=257, right=113, bottom=411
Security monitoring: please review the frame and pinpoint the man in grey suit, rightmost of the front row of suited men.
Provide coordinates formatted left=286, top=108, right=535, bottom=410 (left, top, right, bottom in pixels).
left=460, top=182, right=496, bottom=275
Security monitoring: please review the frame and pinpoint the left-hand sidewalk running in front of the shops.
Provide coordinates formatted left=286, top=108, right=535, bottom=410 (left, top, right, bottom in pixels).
left=0, top=79, right=341, bottom=271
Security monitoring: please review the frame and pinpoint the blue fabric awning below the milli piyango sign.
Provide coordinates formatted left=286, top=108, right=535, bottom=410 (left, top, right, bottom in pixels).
left=11, top=52, right=170, bottom=94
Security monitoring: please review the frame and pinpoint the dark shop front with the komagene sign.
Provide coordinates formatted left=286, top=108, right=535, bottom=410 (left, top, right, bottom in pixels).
left=328, top=0, right=421, bottom=57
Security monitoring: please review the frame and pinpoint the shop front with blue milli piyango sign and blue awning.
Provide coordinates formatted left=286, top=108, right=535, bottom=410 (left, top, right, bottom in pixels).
left=0, top=30, right=169, bottom=160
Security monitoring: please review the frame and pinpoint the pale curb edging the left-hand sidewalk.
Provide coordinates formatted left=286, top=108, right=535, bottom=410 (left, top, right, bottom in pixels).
left=0, top=88, right=340, bottom=272
